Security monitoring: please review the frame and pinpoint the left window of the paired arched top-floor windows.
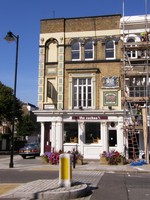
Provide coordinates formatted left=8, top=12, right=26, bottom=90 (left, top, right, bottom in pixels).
left=71, top=42, right=81, bottom=60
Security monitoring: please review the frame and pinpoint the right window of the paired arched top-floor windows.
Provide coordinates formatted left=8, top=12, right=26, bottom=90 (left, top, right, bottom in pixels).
left=84, top=41, right=94, bottom=60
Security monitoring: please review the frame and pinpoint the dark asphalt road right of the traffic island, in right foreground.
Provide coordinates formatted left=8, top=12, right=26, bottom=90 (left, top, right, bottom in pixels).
left=90, top=173, right=150, bottom=200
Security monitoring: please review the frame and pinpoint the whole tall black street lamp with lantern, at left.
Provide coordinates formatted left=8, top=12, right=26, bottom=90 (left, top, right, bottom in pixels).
left=4, top=31, right=19, bottom=168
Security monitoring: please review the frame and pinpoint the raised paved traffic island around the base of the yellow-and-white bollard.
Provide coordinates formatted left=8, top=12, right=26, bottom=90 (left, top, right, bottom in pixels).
left=0, top=171, right=103, bottom=200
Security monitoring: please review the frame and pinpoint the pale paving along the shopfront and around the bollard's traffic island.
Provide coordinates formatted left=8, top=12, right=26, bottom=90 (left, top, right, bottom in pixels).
left=0, top=156, right=150, bottom=200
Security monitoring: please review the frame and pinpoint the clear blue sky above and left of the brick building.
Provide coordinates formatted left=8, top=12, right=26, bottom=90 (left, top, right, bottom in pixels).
left=0, top=0, right=150, bottom=106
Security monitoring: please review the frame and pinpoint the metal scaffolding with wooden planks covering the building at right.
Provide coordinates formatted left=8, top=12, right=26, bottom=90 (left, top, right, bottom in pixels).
left=122, top=0, right=150, bottom=163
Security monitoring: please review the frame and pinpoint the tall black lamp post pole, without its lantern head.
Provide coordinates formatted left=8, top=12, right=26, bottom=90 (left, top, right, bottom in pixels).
left=9, top=35, right=19, bottom=168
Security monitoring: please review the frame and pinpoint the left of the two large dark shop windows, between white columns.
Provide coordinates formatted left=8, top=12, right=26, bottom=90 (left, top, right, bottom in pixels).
left=64, top=122, right=78, bottom=143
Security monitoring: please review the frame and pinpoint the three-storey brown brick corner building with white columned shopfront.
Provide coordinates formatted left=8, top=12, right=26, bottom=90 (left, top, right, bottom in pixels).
left=34, top=15, right=125, bottom=159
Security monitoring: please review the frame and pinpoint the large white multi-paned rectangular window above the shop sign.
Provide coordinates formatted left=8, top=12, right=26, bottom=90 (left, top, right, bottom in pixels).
left=73, top=78, right=92, bottom=108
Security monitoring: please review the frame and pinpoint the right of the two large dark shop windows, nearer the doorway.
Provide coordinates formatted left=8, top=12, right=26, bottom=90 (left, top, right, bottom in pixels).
left=85, top=122, right=101, bottom=144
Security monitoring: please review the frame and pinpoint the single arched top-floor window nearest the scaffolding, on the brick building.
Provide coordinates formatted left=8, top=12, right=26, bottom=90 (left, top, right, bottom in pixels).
left=105, top=40, right=115, bottom=59
